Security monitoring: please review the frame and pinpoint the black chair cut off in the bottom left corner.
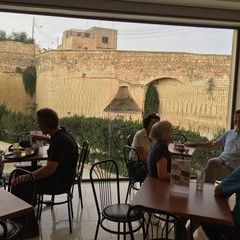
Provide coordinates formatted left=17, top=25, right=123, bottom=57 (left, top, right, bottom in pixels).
left=0, top=220, right=20, bottom=240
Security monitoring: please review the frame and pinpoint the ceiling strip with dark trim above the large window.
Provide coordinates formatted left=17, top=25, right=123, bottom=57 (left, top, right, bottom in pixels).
left=0, top=0, right=240, bottom=29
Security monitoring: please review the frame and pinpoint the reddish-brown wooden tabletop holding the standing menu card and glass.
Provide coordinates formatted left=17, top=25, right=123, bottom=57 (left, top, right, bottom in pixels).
left=132, top=177, right=233, bottom=225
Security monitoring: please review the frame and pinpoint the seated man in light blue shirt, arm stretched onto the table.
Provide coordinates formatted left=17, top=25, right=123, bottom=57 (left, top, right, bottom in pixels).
left=185, top=110, right=240, bottom=183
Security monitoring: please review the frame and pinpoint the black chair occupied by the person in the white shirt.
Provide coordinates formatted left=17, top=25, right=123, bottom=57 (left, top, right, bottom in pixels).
left=123, top=145, right=147, bottom=203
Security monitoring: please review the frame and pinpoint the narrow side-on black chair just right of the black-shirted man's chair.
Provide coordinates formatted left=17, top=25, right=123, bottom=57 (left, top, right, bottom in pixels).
left=75, top=140, right=90, bottom=208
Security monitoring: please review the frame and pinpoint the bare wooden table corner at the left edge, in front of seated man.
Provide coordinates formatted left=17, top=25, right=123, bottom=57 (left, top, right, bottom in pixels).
left=0, top=188, right=33, bottom=219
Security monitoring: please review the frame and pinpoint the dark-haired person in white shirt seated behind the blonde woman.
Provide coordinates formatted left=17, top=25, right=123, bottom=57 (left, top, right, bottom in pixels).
left=131, top=114, right=160, bottom=161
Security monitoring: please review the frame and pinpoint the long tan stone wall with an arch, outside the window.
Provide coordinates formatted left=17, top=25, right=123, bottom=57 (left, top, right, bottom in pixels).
left=36, top=50, right=231, bottom=136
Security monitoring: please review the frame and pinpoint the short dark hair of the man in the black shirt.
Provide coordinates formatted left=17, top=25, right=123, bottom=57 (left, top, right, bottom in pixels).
left=37, top=108, right=58, bottom=129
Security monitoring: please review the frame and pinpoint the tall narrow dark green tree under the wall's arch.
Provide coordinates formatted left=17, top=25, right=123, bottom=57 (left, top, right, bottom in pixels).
left=144, top=84, right=159, bottom=115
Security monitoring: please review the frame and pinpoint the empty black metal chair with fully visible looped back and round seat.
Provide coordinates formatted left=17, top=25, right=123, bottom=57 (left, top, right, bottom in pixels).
left=90, top=160, right=141, bottom=240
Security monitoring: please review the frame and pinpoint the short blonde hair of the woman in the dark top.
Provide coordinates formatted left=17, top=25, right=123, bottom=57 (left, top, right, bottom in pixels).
left=149, top=121, right=172, bottom=141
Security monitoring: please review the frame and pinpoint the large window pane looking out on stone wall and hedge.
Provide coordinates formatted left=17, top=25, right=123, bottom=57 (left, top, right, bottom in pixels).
left=0, top=13, right=233, bottom=177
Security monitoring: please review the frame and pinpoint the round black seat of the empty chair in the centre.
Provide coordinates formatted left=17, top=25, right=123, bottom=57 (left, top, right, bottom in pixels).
left=102, top=203, right=141, bottom=222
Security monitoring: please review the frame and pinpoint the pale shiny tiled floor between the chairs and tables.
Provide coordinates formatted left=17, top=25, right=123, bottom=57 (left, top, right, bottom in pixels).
left=26, top=182, right=206, bottom=240
